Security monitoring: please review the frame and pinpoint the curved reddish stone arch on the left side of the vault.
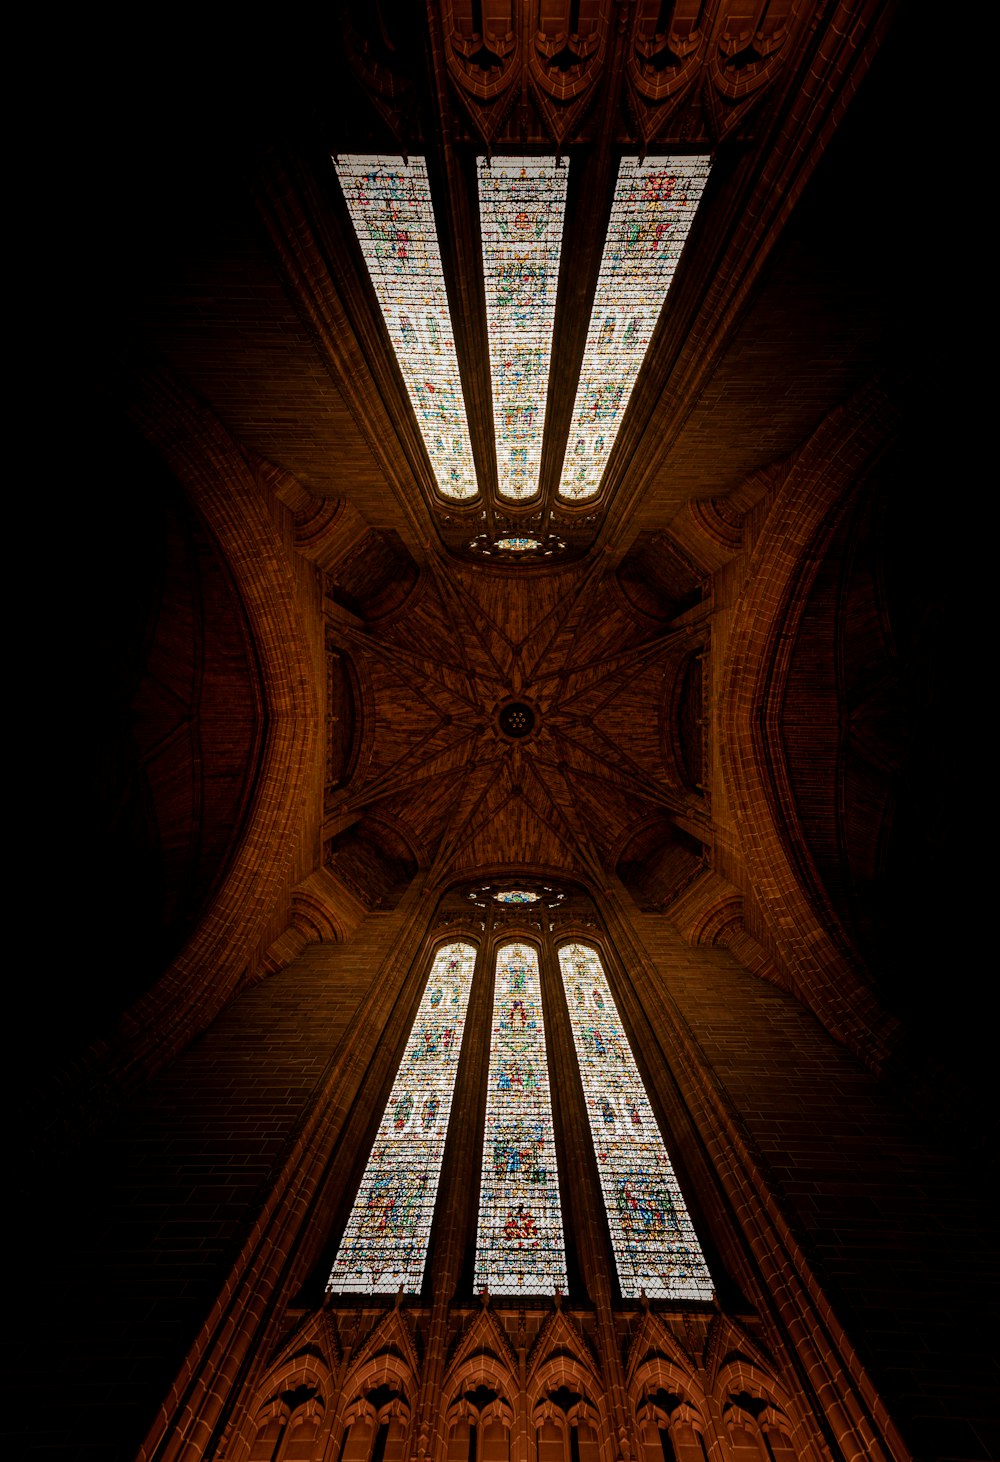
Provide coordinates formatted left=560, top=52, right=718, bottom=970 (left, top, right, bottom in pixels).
left=60, top=368, right=320, bottom=1127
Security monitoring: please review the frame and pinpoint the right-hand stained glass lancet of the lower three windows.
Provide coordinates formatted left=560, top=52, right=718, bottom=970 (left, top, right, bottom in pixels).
left=558, top=944, right=712, bottom=1300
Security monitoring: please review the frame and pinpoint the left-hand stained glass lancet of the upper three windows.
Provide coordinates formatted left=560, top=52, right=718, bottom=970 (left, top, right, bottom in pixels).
left=333, top=155, right=478, bottom=499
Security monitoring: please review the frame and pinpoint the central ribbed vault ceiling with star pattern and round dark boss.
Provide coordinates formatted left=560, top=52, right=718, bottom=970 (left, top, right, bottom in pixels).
left=325, top=549, right=711, bottom=885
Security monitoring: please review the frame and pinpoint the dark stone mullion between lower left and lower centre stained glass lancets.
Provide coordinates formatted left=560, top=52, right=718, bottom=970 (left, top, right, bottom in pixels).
left=409, top=931, right=493, bottom=1459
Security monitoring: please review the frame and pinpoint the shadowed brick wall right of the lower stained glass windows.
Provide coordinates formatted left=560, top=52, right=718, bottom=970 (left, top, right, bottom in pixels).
left=635, top=915, right=1000, bottom=1459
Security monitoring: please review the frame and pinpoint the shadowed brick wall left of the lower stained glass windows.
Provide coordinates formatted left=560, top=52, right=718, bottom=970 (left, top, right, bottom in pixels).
left=15, top=914, right=399, bottom=1462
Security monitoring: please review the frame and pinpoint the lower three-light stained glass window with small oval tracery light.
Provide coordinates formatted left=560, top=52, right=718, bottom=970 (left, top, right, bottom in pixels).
left=327, top=885, right=713, bottom=1301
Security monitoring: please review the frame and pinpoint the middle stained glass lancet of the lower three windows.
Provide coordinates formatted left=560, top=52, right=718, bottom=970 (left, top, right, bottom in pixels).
left=475, top=943, right=566, bottom=1294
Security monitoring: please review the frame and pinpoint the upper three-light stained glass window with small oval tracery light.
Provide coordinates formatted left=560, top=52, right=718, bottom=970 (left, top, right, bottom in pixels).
left=333, top=155, right=711, bottom=532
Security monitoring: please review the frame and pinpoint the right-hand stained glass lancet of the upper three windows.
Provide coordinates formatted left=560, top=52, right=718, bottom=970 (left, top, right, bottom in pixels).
left=558, top=156, right=711, bottom=500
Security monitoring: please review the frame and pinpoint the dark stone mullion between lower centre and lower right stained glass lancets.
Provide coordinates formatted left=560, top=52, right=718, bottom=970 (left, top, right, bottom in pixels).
left=542, top=937, right=637, bottom=1458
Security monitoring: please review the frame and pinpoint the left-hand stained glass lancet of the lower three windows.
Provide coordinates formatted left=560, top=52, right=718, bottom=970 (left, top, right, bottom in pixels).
left=326, top=944, right=475, bottom=1294
